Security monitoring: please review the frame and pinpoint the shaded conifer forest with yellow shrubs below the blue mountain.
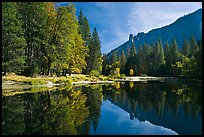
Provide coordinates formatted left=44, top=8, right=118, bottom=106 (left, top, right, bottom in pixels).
left=102, top=36, right=202, bottom=79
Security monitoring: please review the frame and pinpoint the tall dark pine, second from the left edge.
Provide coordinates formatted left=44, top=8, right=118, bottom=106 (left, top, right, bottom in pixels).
left=20, top=2, right=48, bottom=75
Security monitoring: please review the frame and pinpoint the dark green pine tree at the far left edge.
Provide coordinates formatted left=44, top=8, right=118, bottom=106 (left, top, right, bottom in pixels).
left=2, top=2, right=26, bottom=75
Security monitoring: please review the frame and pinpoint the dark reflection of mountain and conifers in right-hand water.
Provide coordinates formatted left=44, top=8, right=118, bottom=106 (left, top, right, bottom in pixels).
left=103, top=82, right=202, bottom=134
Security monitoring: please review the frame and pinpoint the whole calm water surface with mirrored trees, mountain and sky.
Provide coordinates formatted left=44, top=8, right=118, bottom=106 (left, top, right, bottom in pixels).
left=2, top=82, right=202, bottom=135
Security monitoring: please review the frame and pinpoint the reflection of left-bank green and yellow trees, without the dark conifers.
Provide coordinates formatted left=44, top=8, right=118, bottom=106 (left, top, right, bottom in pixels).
left=2, top=85, right=89, bottom=135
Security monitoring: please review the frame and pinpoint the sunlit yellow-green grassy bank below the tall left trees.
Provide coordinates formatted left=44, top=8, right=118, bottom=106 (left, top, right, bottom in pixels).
left=2, top=74, right=114, bottom=89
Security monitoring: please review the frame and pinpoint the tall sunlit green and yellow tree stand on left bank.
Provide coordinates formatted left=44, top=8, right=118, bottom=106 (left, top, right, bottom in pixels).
left=2, top=2, right=102, bottom=76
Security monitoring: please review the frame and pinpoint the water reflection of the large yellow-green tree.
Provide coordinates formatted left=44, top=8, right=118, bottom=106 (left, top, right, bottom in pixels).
left=46, top=88, right=88, bottom=135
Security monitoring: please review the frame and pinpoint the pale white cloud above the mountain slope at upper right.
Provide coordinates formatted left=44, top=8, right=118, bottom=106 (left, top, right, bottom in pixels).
left=127, top=2, right=202, bottom=34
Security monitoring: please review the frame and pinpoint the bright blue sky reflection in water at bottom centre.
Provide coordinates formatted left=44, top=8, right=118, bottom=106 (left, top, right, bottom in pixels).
left=91, top=100, right=177, bottom=135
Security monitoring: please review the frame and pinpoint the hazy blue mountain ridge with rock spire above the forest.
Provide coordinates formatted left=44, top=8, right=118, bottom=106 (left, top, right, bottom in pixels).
left=107, top=8, right=202, bottom=56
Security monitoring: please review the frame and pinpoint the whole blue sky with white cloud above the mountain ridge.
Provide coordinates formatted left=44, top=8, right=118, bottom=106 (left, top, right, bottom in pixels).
left=58, top=2, right=202, bottom=53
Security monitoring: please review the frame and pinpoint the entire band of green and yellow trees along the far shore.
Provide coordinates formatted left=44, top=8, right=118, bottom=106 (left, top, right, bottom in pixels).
left=2, top=2, right=202, bottom=79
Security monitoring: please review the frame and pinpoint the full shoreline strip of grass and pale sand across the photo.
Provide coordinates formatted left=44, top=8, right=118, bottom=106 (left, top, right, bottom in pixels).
left=2, top=74, right=202, bottom=90
